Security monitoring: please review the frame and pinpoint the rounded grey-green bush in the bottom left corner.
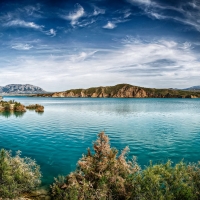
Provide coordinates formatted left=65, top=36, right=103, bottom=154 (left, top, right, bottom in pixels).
left=0, top=149, right=41, bottom=198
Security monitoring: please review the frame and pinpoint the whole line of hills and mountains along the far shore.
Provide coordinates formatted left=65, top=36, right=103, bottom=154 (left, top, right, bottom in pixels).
left=0, top=84, right=200, bottom=98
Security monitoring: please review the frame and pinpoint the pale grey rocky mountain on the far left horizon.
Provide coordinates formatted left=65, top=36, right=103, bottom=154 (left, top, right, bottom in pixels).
left=0, top=84, right=46, bottom=95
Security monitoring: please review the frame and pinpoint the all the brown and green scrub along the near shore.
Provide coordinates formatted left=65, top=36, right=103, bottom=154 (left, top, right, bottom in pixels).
left=0, top=132, right=200, bottom=200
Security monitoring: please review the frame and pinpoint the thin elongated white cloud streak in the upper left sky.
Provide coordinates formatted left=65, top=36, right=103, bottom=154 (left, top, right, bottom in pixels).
left=4, top=19, right=44, bottom=30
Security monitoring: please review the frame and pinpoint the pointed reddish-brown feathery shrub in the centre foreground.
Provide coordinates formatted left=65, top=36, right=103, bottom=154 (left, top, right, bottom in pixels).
left=51, top=132, right=139, bottom=200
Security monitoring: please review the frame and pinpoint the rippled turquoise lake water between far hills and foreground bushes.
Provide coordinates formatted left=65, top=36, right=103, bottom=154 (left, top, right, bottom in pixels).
left=0, top=97, right=200, bottom=185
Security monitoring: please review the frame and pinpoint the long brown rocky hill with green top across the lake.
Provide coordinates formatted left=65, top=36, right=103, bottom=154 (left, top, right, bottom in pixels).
left=33, top=84, right=200, bottom=98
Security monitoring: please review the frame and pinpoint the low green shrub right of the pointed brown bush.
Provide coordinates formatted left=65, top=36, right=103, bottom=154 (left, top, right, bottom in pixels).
left=130, top=161, right=198, bottom=200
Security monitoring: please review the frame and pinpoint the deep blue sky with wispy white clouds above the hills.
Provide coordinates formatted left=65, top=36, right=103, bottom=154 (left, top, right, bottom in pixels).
left=0, top=0, right=200, bottom=91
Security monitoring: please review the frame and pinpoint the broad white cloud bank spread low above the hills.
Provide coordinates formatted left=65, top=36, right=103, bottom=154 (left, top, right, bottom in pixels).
left=0, top=39, right=200, bottom=91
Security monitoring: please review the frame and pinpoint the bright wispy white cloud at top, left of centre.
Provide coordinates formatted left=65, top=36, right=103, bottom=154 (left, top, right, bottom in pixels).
left=64, top=3, right=85, bottom=26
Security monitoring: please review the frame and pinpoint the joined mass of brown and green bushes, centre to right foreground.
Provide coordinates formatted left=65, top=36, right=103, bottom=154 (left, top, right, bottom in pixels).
left=51, top=132, right=200, bottom=200
